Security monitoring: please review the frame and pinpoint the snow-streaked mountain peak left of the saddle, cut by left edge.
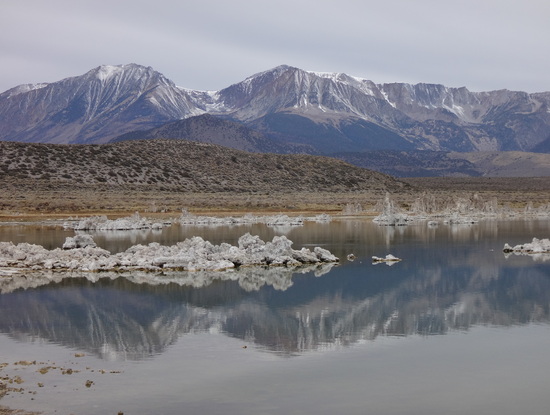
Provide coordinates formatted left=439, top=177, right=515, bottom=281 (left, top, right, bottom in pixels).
left=0, top=64, right=200, bottom=143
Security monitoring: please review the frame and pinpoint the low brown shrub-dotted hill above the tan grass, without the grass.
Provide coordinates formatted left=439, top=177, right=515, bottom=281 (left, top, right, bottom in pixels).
left=0, top=139, right=410, bottom=193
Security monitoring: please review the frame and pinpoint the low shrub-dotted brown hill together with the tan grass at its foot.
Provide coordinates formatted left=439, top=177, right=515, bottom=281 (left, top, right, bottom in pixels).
left=0, top=140, right=410, bottom=213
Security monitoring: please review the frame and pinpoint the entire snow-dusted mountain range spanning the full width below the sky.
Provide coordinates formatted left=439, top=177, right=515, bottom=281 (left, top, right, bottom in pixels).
left=0, top=64, right=550, bottom=153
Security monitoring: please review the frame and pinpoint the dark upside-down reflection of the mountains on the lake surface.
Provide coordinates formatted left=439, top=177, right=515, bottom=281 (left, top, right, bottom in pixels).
left=0, top=219, right=550, bottom=360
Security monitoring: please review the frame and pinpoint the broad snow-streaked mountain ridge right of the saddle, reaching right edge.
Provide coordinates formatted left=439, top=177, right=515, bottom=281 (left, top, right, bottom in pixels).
left=213, top=66, right=550, bottom=151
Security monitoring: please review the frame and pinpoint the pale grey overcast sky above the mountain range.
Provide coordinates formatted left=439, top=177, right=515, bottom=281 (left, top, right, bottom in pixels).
left=0, top=0, right=550, bottom=92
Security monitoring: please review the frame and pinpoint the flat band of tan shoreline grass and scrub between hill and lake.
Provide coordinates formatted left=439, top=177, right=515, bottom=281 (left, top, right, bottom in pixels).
left=0, top=177, right=550, bottom=222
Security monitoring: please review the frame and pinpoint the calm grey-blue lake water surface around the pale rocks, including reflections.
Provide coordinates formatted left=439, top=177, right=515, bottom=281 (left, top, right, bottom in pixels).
left=0, top=220, right=550, bottom=415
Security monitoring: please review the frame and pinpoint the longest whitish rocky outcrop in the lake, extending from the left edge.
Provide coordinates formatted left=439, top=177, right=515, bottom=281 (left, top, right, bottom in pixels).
left=0, top=233, right=338, bottom=277
